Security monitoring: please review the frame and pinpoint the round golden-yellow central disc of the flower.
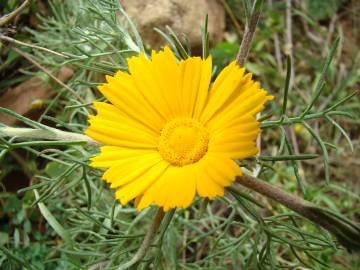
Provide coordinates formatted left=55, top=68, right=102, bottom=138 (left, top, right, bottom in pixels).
left=158, top=118, right=209, bottom=166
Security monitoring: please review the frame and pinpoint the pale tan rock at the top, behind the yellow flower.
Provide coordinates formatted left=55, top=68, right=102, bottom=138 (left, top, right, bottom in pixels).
left=120, top=0, right=225, bottom=49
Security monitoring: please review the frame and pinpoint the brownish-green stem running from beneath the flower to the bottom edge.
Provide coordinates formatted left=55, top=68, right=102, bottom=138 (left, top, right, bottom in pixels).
left=118, top=207, right=165, bottom=270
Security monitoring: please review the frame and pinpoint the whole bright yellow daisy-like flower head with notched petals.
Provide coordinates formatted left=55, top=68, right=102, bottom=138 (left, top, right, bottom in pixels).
left=85, top=47, right=272, bottom=211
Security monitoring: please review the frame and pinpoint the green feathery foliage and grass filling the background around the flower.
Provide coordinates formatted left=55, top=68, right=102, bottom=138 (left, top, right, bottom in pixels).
left=0, top=0, right=360, bottom=270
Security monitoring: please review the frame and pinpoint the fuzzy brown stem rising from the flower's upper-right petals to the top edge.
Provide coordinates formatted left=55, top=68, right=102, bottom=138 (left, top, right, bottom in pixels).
left=236, top=0, right=263, bottom=67
